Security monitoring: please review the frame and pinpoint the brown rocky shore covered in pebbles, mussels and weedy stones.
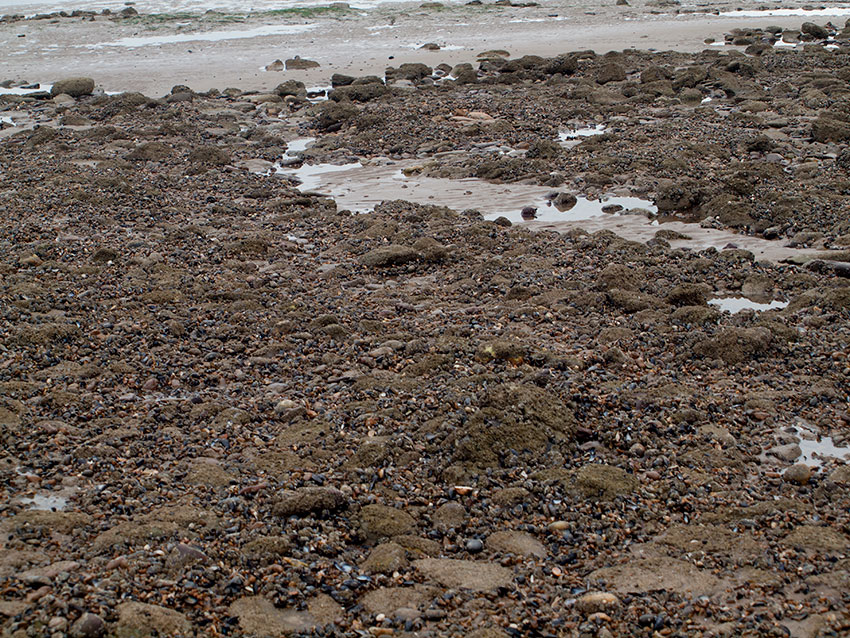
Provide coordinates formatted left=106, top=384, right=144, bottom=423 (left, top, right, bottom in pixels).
left=0, top=25, right=850, bottom=638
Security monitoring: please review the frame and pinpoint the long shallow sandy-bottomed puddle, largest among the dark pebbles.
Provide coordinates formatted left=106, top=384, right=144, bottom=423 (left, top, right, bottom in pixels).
left=270, top=140, right=836, bottom=262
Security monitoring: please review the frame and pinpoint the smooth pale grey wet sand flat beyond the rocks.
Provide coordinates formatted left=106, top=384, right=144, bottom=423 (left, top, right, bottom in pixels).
left=6, top=3, right=850, bottom=95
